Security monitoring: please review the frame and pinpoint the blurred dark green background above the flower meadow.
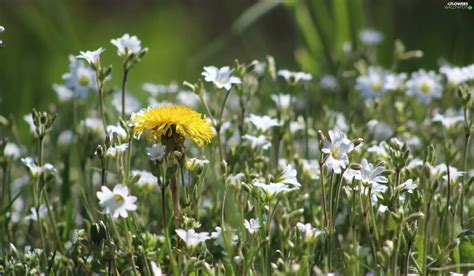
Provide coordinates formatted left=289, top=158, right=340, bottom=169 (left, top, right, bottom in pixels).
left=0, top=0, right=474, bottom=117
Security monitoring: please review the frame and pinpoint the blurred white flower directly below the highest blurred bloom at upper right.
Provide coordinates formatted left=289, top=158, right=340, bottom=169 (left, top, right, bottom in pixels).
left=355, top=66, right=388, bottom=100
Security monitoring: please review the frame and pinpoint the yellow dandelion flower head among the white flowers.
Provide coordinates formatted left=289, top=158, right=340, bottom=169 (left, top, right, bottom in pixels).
left=132, top=105, right=215, bottom=147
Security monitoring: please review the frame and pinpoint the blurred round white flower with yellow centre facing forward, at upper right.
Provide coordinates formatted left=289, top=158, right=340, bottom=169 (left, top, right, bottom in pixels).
left=407, top=69, right=442, bottom=104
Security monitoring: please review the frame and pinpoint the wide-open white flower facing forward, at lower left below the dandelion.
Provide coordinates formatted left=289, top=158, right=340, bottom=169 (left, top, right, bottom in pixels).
left=97, top=184, right=137, bottom=218
